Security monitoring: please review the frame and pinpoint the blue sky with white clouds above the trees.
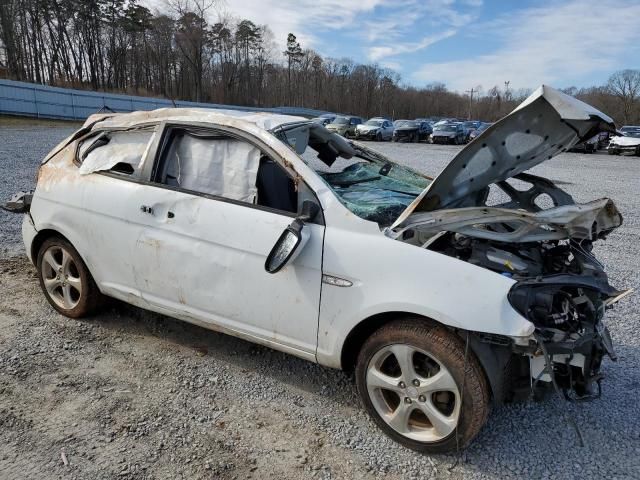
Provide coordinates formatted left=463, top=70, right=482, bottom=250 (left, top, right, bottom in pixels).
left=148, top=0, right=640, bottom=91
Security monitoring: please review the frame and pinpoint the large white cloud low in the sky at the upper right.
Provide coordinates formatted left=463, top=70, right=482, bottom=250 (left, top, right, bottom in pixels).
left=412, top=0, right=640, bottom=91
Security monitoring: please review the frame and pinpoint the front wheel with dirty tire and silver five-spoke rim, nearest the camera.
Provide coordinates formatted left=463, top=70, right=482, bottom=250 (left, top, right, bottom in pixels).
left=356, top=319, right=489, bottom=453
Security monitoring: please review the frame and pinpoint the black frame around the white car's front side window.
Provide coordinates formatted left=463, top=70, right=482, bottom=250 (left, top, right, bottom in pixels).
left=141, top=120, right=325, bottom=226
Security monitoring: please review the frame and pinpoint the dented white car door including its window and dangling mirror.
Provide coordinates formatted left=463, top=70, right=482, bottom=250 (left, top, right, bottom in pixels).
left=129, top=125, right=324, bottom=358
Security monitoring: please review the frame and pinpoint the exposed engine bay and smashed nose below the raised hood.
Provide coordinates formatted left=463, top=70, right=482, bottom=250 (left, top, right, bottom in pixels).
left=387, top=174, right=628, bottom=399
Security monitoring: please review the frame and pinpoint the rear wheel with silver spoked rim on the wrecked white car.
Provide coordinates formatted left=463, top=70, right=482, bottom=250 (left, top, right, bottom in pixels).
left=36, top=237, right=105, bottom=318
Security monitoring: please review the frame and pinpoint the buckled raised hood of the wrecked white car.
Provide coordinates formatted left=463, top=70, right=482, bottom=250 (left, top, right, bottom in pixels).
left=391, top=85, right=615, bottom=229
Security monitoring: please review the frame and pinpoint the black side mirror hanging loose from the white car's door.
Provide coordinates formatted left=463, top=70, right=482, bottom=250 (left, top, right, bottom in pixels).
left=264, top=200, right=319, bottom=273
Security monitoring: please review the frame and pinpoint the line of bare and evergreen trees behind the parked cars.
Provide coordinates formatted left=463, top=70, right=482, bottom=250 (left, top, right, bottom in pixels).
left=0, top=0, right=640, bottom=124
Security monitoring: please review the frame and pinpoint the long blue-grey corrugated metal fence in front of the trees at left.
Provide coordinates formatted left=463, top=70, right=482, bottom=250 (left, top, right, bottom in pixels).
left=0, top=80, right=327, bottom=120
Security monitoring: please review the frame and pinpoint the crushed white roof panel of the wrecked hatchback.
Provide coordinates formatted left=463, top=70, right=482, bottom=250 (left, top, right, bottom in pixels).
left=84, top=108, right=307, bottom=130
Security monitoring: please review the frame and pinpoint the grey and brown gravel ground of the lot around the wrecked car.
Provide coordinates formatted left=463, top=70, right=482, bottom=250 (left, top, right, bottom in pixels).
left=0, top=122, right=640, bottom=479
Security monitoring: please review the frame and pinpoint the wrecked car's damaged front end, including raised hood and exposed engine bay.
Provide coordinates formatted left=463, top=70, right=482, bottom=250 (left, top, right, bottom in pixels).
left=385, top=87, right=631, bottom=399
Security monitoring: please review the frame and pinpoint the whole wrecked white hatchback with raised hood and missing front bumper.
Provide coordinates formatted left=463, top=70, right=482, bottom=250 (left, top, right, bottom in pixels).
left=7, top=87, right=628, bottom=452
